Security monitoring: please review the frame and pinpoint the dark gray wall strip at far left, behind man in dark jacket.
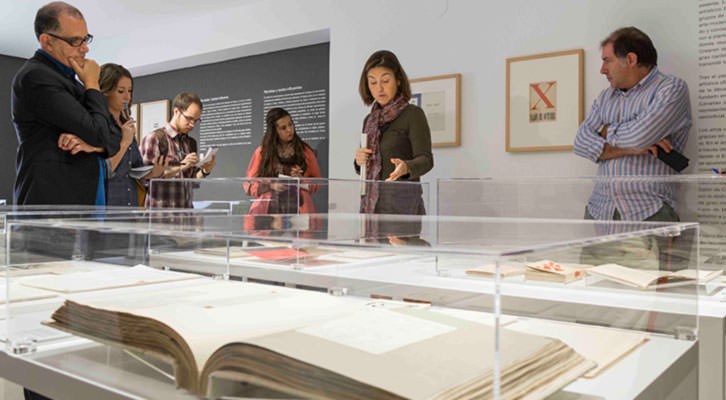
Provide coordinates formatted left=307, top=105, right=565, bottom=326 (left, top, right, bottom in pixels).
left=0, top=54, right=25, bottom=203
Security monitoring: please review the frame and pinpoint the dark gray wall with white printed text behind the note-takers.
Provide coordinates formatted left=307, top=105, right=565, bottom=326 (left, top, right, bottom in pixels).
left=134, top=43, right=330, bottom=177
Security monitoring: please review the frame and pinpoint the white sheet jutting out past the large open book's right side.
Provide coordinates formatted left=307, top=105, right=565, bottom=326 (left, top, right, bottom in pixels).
left=507, top=319, right=648, bottom=378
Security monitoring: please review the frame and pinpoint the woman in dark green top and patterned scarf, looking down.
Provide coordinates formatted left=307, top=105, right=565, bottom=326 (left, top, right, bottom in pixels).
left=355, top=50, right=434, bottom=215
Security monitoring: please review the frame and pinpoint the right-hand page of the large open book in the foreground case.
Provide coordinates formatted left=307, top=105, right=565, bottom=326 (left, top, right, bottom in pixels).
left=249, top=309, right=551, bottom=399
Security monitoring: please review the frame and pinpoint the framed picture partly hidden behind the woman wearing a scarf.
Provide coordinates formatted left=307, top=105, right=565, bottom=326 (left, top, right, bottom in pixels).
left=410, top=74, right=461, bottom=147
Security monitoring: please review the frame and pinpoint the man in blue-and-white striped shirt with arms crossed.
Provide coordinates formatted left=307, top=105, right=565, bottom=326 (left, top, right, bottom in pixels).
left=574, top=27, right=692, bottom=221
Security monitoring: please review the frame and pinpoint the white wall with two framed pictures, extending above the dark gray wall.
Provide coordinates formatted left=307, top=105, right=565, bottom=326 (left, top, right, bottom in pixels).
left=4, top=0, right=697, bottom=181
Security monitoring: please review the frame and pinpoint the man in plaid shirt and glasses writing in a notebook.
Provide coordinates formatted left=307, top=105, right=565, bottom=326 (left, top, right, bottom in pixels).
left=141, top=93, right=215, bottom=208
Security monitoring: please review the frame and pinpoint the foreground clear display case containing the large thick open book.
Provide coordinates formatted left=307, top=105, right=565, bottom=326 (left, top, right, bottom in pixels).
left=2, top=212, right=706, bottom=399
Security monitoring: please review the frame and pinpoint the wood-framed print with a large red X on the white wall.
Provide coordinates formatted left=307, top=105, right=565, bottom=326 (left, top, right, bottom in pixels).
left=506, top=49, right=584, bottom=151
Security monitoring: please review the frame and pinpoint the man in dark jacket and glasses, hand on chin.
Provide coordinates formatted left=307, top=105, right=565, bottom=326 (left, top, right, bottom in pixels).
left=11, top=2, right=121, bottom=205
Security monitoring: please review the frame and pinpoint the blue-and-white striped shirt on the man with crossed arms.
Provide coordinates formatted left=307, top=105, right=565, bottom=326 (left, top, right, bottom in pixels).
left=574, top=67, right=693, bottom=221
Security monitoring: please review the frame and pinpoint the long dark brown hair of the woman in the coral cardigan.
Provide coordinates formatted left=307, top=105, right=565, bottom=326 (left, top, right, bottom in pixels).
left=257, top=107, right=310, bottom=178
